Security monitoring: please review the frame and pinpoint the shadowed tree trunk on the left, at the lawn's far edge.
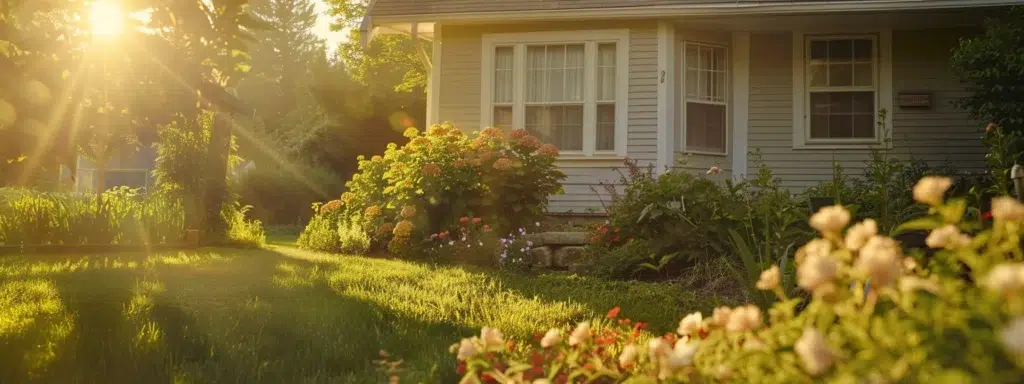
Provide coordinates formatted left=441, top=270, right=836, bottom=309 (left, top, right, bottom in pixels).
left=203, top=109, right=231, bottom=241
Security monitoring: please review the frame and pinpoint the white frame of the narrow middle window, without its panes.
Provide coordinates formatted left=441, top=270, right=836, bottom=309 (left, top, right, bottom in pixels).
left=677, top=40, right=732, bottom=156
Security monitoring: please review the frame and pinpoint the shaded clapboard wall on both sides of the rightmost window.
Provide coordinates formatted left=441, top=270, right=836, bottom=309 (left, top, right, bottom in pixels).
left=748, top=29, right=985, bottom=191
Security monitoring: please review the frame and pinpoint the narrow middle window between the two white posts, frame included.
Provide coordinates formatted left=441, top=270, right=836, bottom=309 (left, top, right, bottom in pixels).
left=681, top=42, right=729, bottom=154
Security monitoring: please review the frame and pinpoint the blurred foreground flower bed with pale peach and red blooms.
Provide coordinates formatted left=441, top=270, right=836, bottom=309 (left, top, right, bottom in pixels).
left=452, top=177, right=1024, bottom=383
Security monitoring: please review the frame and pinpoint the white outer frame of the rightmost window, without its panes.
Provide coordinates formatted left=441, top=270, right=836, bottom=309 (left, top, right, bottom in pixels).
left=793, top=28, right=894, bottom=150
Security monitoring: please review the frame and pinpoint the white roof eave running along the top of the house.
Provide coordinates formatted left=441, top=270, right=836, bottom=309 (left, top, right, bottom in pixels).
left=359, top=0, right=1021, bottom=44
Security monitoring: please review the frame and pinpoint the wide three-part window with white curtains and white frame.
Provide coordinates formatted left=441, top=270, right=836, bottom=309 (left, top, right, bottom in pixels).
left=481, top=31, right=629, bottom=156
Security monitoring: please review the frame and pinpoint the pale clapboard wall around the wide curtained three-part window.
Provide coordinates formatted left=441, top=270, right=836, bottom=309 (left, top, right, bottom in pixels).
left=438, top=20, right=657, bottom=214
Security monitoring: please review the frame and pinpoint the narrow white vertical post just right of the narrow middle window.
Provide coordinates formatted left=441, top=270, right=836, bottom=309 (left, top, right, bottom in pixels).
left=730, top=31, right=751, bottom=180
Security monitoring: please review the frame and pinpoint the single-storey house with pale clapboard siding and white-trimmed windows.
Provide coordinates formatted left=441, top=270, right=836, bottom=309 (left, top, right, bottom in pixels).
left=361, top=0, right=1024, bottom=213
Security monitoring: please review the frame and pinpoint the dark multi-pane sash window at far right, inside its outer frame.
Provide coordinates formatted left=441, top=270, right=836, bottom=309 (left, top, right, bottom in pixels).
left=806, top=36, right=879, bottom=140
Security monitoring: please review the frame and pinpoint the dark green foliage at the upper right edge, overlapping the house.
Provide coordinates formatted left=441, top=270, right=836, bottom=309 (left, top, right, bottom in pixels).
left=952, top=6, right=1024, bottom=132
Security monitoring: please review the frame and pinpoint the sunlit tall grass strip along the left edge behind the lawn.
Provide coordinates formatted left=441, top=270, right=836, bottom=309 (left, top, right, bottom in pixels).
left=0, top=187, right=184, bottom=245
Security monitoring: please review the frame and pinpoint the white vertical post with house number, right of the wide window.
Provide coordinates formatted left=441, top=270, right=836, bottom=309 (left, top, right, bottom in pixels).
left=657, top=22, right=677, bottom=174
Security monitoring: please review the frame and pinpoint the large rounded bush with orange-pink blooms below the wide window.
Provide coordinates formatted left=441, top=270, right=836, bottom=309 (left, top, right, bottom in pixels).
left=303, top=124, right=565, bottom=259
